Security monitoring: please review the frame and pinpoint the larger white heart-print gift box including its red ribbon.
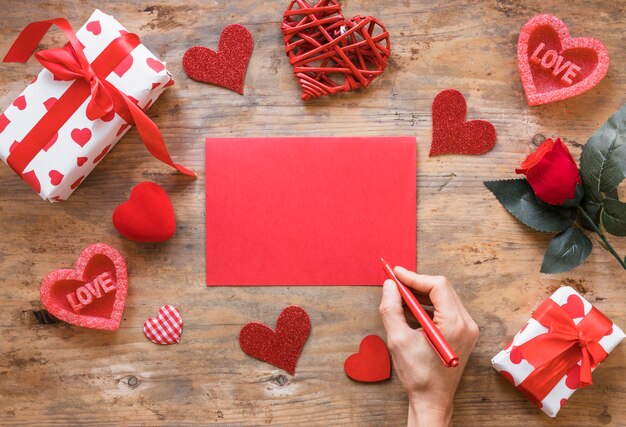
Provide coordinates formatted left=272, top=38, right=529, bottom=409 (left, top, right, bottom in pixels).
left=0, top=10, right=191, bottom=201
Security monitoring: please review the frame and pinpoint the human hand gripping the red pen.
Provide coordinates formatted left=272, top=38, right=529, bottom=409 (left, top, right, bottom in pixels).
left=379, top=267, right=479, bottom=427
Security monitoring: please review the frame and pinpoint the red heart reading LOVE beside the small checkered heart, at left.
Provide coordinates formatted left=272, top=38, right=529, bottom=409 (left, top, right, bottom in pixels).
left=39, top=243, right=128, bottom=331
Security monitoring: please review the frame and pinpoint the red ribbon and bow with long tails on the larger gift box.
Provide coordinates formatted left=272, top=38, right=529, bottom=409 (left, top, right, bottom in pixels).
left=3, top=18, right=195, bottom=176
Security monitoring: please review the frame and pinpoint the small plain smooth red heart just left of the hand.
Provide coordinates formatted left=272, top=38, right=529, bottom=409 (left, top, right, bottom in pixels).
left=343, top=335, right=391, bottom=382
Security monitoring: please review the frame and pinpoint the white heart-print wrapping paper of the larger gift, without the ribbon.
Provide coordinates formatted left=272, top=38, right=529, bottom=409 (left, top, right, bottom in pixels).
left=0, top=10, right=173, bottom=201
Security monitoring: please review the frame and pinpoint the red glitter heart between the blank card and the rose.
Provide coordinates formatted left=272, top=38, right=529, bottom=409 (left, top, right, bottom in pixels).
left=429, top=89, right=496, bottom=157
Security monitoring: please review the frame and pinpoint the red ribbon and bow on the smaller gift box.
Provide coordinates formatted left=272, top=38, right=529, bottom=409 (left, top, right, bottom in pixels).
left=517, top=298, right=613, bottom=403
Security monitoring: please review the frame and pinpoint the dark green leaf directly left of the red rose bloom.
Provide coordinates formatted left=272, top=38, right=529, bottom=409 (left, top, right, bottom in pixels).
left=484, top=178, right=576, bottom=233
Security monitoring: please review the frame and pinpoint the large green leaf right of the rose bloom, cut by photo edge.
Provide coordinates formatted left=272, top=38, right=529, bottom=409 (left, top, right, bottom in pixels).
left=580, top=104, right=626, bottom=196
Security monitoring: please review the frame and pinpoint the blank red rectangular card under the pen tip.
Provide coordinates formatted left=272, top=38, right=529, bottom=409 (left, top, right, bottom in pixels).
left=206, top=137, right=417, bottom=286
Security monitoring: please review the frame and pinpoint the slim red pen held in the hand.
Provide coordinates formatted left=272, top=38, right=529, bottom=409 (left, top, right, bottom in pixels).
left=380, top=258, right=459, bottom=368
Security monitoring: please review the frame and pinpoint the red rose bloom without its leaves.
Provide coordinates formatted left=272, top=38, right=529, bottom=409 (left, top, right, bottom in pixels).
left=515, top=138, right=581, bottom=206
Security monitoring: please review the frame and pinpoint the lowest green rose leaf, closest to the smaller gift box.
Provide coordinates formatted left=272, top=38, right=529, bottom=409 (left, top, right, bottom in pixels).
left=541, top=227, right=591, bottom=274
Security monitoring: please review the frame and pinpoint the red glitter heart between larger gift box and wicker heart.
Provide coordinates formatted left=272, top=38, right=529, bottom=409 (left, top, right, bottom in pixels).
left=183, top=24, right=254, bottom=95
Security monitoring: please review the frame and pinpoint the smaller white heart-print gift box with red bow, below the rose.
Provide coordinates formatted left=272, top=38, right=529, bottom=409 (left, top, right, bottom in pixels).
left=491, top=286, right=624, bottom=417
